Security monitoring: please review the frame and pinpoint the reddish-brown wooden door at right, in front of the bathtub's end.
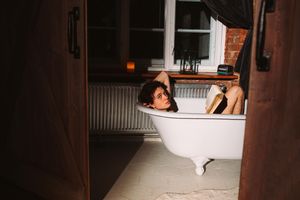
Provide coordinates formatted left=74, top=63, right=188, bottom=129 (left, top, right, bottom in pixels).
left=239, top=0, right=300, bottom=200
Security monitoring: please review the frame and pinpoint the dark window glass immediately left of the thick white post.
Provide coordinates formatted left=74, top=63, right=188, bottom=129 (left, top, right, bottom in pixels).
left=129, top=0, right=165, bottom=63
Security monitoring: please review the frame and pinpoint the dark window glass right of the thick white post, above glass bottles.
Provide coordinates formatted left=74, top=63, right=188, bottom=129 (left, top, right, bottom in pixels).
left=174, top=1, right=211, bottom=64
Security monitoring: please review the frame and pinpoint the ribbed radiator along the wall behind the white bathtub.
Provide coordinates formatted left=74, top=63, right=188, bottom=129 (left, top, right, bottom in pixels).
left=89, top=83, right=210, bottom=135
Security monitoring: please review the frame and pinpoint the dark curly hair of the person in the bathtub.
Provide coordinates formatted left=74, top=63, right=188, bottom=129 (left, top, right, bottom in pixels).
left=138, top=81, right=170, bottom=104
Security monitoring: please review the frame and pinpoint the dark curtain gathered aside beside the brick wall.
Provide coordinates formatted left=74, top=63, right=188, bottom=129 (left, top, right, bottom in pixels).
left=203, top=0, right=253, bottom=98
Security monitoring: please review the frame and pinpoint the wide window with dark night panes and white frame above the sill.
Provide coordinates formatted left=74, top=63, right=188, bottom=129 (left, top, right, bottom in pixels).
left=88, top=0, right=225, bottom=71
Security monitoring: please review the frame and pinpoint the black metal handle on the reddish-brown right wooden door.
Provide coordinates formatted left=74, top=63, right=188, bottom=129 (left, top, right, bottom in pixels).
left=256, top=0, right=275, bottom=71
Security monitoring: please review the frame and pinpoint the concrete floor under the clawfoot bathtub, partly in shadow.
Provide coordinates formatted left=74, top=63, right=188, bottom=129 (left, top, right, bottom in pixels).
left=90, top=140, right=241, bottom=200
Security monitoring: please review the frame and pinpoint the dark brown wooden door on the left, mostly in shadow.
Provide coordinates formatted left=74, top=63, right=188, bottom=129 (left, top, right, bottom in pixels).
left=0, top=0, right=89, bottom=200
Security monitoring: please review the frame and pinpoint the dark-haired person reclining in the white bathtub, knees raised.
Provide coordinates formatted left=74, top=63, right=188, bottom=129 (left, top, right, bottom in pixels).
left=138, top=71, right=244, bottom=114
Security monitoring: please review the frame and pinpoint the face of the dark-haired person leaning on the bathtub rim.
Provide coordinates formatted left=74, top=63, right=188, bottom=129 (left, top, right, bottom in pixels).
left=150, top=87, right=171, bottom=110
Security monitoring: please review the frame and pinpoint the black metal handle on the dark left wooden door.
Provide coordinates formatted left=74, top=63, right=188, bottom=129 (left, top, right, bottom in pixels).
left=68, top=7, right=80, bottom=58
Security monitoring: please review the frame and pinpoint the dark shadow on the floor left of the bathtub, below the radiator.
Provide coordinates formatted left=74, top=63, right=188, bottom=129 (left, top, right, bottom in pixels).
left=89, top=136, right=143, bottom=200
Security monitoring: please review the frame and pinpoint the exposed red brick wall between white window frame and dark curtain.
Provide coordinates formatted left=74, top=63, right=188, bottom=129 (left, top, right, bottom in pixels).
left=224, top=28, right=247, bottom=66
